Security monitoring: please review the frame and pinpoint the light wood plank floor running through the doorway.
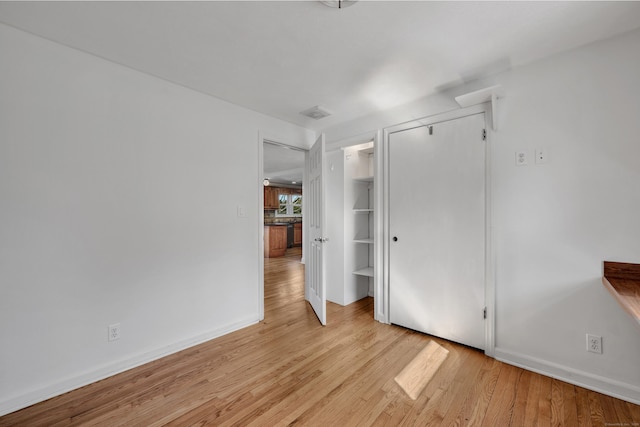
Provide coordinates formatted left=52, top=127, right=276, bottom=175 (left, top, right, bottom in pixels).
left=0, top=250, right=640, bottom=427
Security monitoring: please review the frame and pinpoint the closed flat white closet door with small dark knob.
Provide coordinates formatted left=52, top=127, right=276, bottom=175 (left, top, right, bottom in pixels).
left=389, top=114, right=485, bottom=349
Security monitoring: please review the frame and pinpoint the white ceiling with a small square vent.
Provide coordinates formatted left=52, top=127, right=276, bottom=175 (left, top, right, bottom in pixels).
left=0, top=0, right=640, bottom=130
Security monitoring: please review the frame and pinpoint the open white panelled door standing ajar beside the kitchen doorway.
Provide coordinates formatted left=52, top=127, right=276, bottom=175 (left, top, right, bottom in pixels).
left=305, top=134, right=328, bottom=325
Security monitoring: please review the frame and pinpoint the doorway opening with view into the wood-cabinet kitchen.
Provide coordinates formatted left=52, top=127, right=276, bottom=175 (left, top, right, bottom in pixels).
left=258, top=139, right=308, bottom=320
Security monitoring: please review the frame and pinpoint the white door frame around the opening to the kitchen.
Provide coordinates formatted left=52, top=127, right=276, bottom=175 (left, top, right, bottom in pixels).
left=257, top=132, right=309, bottom=321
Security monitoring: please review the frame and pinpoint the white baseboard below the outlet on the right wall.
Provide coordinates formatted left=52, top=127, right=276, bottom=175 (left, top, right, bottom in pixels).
left=495, top=347, right=640, bottom=405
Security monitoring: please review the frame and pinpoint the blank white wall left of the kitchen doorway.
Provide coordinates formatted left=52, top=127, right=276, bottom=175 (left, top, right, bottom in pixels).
left=0, top=25, right=313, bottom=414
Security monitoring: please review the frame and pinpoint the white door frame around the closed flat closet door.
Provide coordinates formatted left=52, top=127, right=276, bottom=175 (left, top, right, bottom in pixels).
left=375, top=103, right=495, bottom=357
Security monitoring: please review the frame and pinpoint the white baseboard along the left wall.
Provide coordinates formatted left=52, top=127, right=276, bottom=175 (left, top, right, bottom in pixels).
left=0, top=317, right=258, bottom=416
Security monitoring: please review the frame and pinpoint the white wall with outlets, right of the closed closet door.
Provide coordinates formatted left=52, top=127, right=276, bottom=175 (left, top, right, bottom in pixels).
left=325, top=31, right=640, bottom=403
